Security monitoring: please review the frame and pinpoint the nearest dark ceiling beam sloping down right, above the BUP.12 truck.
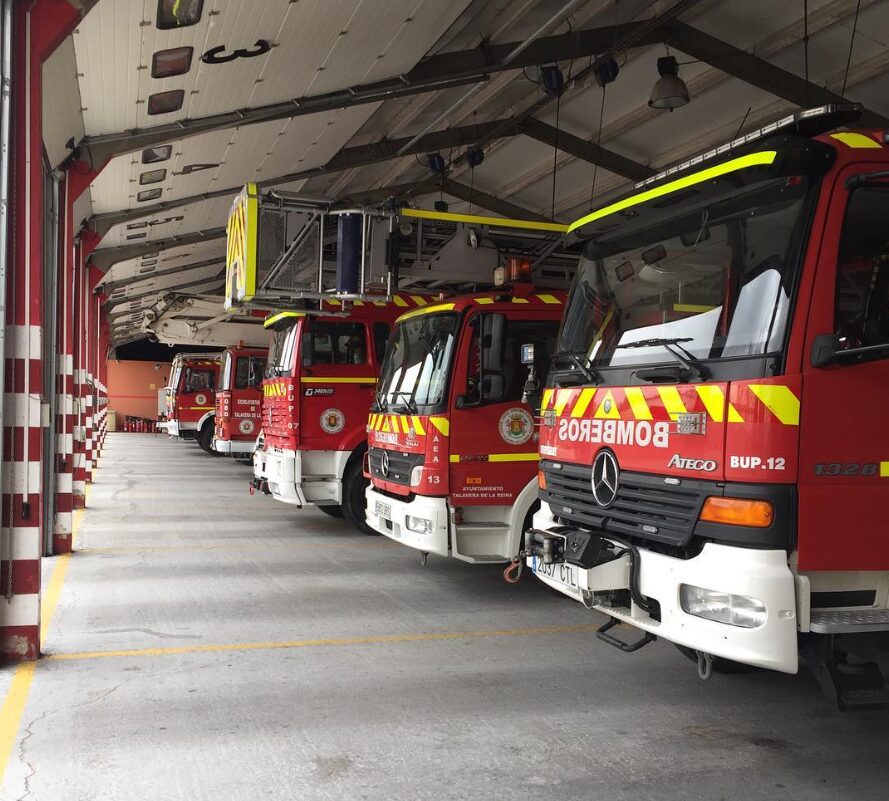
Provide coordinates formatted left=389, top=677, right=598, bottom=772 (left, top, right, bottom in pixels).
left=661, top=20, right=889, bottom=128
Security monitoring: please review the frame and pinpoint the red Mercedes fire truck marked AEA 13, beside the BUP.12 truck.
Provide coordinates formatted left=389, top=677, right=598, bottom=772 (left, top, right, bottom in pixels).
left=367, top=283, right=565, bottom=563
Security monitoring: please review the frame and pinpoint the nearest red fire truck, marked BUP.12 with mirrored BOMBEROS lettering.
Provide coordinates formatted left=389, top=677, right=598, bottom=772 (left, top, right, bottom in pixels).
left=525, top=107, right=889, bottom=709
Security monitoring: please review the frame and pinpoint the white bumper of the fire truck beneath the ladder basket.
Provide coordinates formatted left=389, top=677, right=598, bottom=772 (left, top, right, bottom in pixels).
left=253, top=448, right=351, bottom=506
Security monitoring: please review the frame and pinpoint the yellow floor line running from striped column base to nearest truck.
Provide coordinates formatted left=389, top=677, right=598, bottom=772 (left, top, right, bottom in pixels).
left=44, top=624, right=600, bottom=662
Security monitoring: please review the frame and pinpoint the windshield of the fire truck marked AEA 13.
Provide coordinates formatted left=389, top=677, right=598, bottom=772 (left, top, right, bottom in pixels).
left=377, top=313, right=457, bottom=412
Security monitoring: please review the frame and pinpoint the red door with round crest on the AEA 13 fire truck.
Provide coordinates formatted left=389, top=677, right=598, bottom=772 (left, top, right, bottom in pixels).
left=450, top=312, right=559, bottom=506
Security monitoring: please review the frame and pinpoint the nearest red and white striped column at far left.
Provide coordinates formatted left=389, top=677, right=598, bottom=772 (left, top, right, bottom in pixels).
left=0, top=0, right=79, bottom=661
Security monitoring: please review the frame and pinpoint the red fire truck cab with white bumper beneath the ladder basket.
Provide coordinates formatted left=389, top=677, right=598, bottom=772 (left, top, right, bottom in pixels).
left=253, top=294, right=430, bottom=534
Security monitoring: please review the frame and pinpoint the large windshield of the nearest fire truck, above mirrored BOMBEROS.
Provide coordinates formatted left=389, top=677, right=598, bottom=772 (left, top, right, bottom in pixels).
left=554, top=175, right=812, bottom=376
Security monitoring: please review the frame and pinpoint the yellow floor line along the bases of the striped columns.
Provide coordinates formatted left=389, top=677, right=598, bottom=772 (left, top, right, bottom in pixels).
left=0, top=487, right=89, bottom=784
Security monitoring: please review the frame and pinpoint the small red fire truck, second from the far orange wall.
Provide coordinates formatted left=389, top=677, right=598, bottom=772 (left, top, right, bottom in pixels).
left=213, top=343, right=268, bottom=458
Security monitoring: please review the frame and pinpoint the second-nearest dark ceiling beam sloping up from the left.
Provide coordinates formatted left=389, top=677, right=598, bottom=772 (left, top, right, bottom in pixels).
left=87, top=119, right=518, bottom=236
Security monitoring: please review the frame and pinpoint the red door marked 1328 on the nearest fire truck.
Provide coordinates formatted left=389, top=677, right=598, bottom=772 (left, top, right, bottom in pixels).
left=799, top=174, right=889, bottom=571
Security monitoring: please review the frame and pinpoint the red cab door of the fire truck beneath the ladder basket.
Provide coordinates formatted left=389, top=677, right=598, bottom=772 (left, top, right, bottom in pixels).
left=297, top=319, right=377, bottom=450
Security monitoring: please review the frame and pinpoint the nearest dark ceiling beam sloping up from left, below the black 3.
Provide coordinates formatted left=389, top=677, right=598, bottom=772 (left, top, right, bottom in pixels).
left=79, top=22, right=662, bottom=164
